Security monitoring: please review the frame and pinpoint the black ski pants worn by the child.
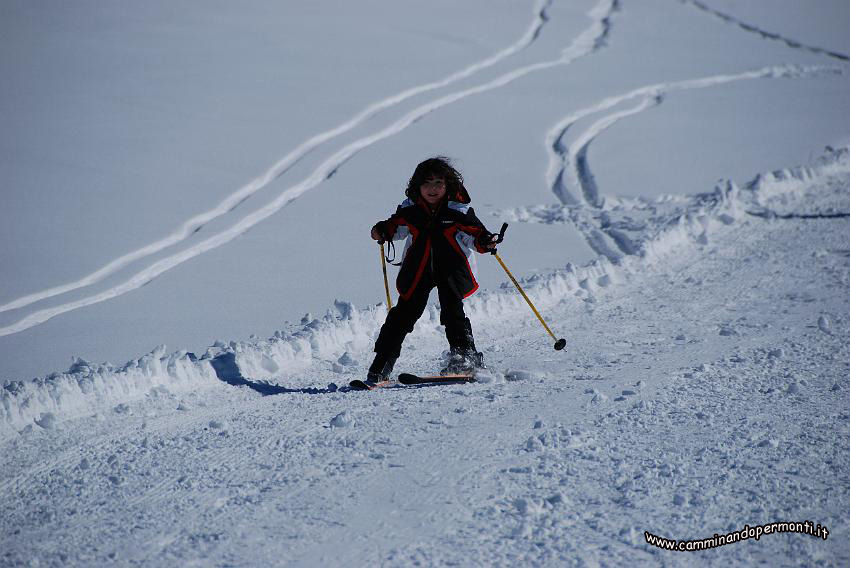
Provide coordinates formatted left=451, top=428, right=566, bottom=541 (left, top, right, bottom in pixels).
left=375, top=272, right=475, bottom=357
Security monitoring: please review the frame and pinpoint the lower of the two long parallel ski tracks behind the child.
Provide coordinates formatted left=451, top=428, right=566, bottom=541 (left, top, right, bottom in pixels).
left=0, top=0, right=618, bottom=337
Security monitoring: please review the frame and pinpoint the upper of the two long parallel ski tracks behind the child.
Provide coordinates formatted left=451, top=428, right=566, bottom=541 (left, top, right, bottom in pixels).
left=0, top=0, right=552, bottom=312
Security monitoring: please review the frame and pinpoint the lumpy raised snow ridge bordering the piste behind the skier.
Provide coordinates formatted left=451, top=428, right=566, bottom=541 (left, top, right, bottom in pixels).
left=0, top=148, right=850, bottom=437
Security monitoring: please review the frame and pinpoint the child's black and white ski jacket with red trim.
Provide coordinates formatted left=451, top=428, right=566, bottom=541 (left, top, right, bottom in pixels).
left=374, top=198, right=492, bottom=300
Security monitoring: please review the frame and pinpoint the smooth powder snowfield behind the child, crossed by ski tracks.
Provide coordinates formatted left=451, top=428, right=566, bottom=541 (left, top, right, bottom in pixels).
left=0, top=0, right=850, bottom=380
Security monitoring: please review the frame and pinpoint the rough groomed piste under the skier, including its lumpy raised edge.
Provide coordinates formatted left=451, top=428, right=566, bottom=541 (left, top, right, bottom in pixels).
left=0, top=150, right=850, bottom=566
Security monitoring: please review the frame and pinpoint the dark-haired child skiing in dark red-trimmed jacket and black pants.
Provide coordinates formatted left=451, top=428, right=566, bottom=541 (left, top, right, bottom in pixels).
left=367, top=157, right=497, bottom=383
